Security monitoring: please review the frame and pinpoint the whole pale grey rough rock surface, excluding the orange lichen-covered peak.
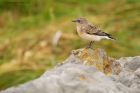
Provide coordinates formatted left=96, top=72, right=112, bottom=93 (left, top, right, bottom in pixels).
left=0, top=48, right=140, bottom=93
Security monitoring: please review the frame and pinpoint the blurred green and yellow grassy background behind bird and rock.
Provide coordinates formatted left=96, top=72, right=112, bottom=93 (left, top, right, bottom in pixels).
left=0, top=0, right=140, bottom=90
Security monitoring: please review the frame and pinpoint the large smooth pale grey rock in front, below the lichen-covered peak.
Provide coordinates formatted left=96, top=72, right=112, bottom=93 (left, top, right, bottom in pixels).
left=1, top=63, right=129, bottom=93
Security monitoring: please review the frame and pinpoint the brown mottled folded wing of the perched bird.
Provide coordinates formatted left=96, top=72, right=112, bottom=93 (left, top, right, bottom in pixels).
left=86, top=25, right=114, bottom=39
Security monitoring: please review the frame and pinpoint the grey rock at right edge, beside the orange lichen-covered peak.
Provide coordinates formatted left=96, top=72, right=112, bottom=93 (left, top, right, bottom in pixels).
left=115, top=56, right=140, bottom=93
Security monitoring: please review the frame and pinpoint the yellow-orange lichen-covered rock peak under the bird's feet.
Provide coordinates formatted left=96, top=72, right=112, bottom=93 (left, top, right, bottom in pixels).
left=72, top=48, right=121, bottom=75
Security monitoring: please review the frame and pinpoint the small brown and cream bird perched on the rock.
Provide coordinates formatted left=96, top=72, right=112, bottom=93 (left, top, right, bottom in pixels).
left=72, top=17, right=115, bottom=48
